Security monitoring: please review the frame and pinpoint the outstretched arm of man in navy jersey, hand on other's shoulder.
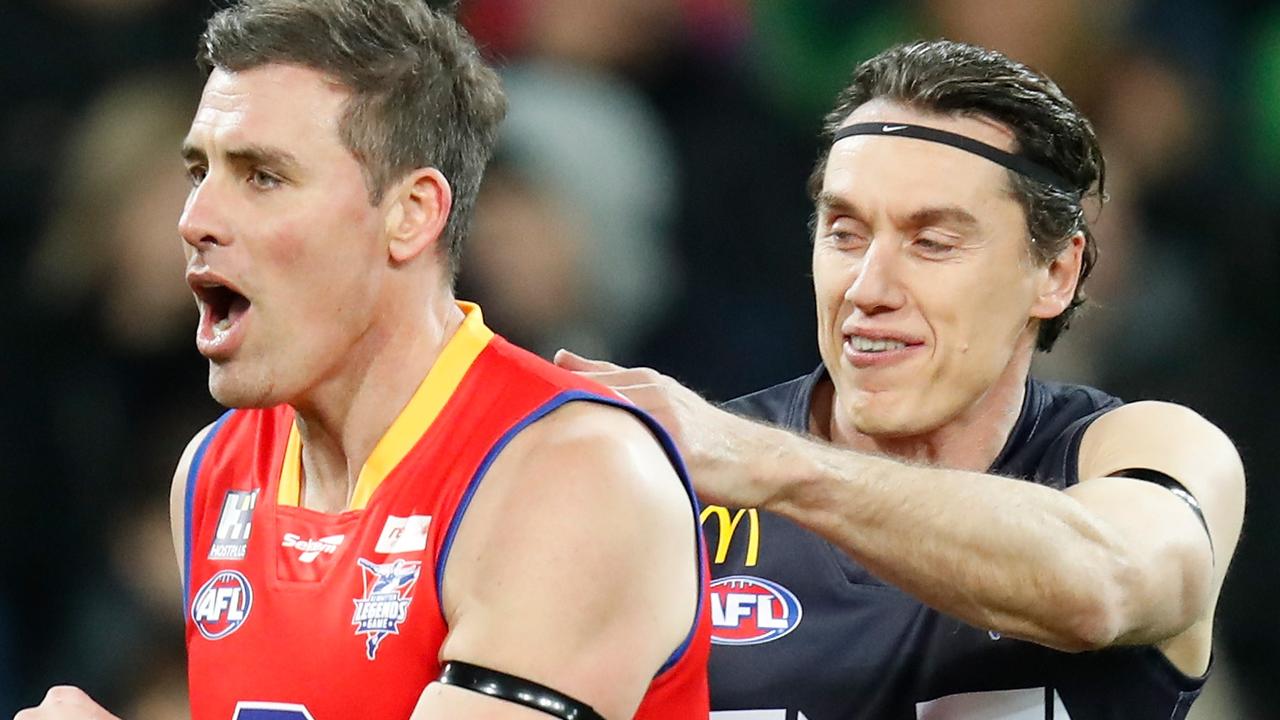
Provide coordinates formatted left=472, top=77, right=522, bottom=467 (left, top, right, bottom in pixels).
left=557, top=355, right=1244, bottom=671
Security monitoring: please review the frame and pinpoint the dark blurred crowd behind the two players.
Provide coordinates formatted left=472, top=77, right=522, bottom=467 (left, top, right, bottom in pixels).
left=0, top=0, right=1280, bottom=720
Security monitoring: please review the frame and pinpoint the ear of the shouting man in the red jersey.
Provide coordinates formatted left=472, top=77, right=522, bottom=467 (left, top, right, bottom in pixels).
left=387, top=168, right=453, bottom=263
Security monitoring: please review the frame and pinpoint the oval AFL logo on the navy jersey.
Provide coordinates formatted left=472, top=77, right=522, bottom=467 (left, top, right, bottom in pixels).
left=710, top=575, right=803, bottom=644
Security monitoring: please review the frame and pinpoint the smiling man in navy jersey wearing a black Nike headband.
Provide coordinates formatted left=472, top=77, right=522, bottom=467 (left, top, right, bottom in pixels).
left=558, top=41, right=1244, bottom=720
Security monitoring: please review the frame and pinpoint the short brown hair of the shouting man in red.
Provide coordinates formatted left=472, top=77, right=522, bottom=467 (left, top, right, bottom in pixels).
left=197, top=0, right=507, bottom=274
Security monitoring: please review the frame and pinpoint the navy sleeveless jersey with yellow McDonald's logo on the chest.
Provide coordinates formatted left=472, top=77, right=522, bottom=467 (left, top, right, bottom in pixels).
left=701, top=368, right=1204, bottom=720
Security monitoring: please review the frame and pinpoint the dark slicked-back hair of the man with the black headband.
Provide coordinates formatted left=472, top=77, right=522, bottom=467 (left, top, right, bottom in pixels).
left=809, top=40, right=1106, bottom=351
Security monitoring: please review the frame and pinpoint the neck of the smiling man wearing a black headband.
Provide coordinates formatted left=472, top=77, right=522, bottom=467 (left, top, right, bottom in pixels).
left=813, top=352, right=1030, bottom=473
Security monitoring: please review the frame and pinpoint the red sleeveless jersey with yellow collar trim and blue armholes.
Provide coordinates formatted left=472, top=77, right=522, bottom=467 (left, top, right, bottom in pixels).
left=183, top=306, right=710, bottom=720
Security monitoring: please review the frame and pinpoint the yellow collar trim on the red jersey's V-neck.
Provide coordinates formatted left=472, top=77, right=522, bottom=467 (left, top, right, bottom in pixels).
left=276, top=301, right=493, bottom=510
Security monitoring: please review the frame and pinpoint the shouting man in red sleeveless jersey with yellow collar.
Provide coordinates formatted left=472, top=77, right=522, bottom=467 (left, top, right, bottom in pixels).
left=19, top=0, right=709, bottom=720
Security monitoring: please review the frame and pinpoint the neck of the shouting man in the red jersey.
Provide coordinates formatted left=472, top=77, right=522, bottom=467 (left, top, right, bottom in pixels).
left=293, top=295, right=465, bottom=512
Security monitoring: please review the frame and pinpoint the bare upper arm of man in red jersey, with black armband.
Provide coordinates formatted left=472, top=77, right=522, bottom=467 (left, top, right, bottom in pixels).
left=413, top=404, right=700, bottom=720
